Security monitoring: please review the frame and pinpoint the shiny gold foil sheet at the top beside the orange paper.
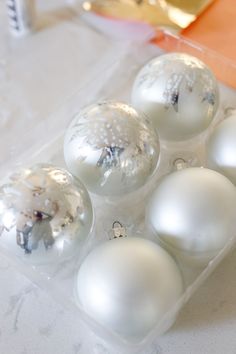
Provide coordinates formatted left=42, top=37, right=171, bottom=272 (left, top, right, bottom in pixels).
left=83, top=0, right=214, bottom=31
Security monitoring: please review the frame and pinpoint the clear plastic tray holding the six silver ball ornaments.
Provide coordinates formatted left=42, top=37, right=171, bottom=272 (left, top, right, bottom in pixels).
left=0, top=32, right=236, bottom=354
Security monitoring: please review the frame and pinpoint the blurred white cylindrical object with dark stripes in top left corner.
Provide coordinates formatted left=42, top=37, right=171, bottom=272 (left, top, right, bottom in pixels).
left=6, top=0, right=35, bottom=36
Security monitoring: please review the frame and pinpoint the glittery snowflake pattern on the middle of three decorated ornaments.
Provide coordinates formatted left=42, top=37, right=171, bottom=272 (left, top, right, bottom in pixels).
left=65, top=102, right=159, bottom=185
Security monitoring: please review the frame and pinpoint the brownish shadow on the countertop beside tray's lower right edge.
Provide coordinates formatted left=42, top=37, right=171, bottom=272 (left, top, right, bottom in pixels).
left=170, top=246, right=236, bottom=332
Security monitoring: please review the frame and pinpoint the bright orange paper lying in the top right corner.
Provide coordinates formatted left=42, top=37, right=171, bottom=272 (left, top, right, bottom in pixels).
left=153, top=0, right=236, bottom=88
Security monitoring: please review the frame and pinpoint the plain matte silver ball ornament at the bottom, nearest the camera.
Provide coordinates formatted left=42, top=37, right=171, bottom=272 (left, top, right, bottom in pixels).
left=76, top=237, right=183, bottom=339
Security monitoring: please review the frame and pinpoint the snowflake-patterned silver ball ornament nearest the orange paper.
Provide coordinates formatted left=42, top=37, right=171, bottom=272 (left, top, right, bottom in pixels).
left=132, top=53, right=219, bottom=141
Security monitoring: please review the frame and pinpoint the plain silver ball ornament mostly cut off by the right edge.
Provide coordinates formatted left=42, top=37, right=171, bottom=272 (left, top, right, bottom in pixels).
left=206, top=114, right=236, bottom=184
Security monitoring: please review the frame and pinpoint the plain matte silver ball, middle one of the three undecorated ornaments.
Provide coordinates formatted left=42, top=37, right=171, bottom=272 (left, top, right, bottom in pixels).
left=146, top=168, right=236, bottom=263
